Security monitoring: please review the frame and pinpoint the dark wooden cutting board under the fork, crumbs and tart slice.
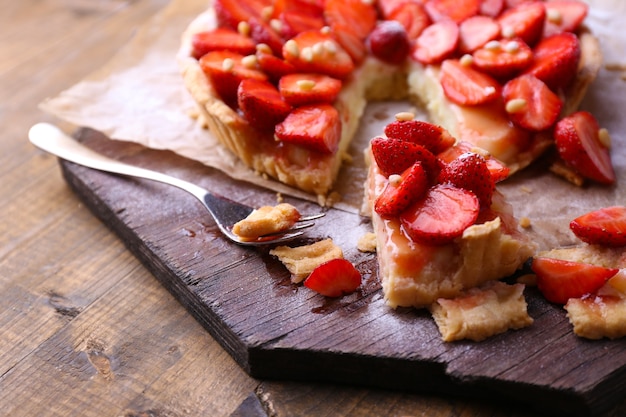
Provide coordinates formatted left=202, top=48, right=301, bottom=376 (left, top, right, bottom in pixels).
left=56, top=129, right=626, bottom=415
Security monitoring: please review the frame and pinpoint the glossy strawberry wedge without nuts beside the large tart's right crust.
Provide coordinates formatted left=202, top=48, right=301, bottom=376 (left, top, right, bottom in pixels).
left=524, top=32, right=580, bottom=91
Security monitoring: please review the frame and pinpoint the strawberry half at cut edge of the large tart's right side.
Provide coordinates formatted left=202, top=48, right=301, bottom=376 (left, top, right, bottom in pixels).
left=439, top=59, right=502, bottom=106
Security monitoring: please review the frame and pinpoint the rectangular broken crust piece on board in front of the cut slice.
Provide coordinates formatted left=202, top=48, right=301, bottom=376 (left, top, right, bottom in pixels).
left=430, top=281, right=533, bottom=342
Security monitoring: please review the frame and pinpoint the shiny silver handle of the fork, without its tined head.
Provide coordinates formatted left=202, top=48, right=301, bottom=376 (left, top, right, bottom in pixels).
left=28, top=123, right=207, bottom=200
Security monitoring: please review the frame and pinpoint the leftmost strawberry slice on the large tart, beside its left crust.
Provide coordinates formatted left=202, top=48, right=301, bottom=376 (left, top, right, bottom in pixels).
left=191, top=28, right=256, bottom=59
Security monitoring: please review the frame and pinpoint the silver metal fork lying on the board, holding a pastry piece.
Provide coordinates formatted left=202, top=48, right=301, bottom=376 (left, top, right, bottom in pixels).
left=28, top=123, right=325, bottom=246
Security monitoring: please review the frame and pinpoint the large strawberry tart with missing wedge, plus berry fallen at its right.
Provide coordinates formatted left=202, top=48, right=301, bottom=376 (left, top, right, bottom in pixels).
left=179, top=0, right=615, bottom=203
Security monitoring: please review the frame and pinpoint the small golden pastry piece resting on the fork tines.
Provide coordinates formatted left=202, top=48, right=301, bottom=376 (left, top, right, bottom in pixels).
left=233, top=203, right=300, bottom=239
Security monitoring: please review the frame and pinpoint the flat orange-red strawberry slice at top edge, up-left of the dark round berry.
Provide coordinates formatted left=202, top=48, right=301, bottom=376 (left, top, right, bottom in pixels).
left=324, top=0, right=377, bottom=41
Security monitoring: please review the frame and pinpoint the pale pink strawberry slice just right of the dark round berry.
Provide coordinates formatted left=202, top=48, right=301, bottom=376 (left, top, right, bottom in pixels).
left=412, top=20, right=459, bottom=64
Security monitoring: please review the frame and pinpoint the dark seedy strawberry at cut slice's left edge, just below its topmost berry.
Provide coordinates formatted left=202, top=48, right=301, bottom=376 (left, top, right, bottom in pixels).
left=371, top=137, right=440, bottom=179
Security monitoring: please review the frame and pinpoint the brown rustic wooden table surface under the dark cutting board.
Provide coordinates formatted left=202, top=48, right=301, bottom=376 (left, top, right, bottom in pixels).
left=0, top=0, right=626, bottom=417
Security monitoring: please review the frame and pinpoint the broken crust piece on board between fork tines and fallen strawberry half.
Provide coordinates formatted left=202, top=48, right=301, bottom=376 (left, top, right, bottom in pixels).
left=270, top=239, right=343, bottom=283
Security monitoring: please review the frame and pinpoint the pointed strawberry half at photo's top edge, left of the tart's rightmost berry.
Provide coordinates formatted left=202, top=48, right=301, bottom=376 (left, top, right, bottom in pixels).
left=498, top=2, right=546, bottom=47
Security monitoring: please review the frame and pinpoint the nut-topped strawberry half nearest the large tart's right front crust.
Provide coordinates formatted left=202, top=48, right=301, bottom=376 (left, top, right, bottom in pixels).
left=502, top=75, right=563, bottom=132
